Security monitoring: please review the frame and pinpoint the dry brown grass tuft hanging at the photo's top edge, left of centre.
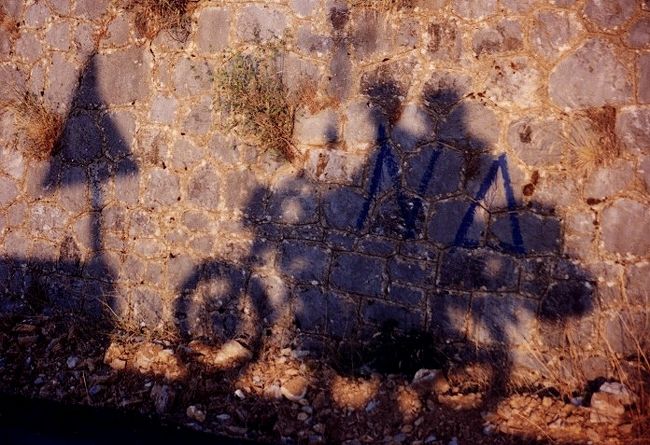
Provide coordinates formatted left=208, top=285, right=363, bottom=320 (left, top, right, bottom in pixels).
left=127, top=0, right=197, bottom=41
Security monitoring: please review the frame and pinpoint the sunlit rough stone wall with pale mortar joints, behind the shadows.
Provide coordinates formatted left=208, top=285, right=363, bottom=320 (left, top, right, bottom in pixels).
left=0, top=0, right=650, bottom=386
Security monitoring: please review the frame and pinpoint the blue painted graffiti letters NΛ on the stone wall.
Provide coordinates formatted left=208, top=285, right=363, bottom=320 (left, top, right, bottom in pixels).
left=357, top=130, right=526, bottom=254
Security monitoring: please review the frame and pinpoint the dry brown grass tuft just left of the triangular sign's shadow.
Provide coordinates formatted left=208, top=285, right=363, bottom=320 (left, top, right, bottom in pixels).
left=2, top=92, right=65, bottom=160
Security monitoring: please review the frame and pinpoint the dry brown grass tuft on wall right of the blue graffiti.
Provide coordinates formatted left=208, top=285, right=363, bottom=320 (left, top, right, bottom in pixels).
left=565, top=106, right=621, bottom=174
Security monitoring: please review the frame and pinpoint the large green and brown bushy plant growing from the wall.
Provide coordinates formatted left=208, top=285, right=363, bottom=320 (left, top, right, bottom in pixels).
left=217, top=49, right=315, bottom=162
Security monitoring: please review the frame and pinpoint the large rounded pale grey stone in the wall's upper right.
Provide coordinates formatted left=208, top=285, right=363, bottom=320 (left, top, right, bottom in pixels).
left=549, top=40, right=632, bottom=108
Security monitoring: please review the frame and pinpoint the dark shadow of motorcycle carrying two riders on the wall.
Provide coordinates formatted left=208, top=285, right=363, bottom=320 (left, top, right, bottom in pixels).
left=175, top=70, right=593, bottom=392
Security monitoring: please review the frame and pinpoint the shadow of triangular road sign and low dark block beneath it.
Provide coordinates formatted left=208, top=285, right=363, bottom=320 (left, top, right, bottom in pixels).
left=0, top=57, right=138, bottom=326
